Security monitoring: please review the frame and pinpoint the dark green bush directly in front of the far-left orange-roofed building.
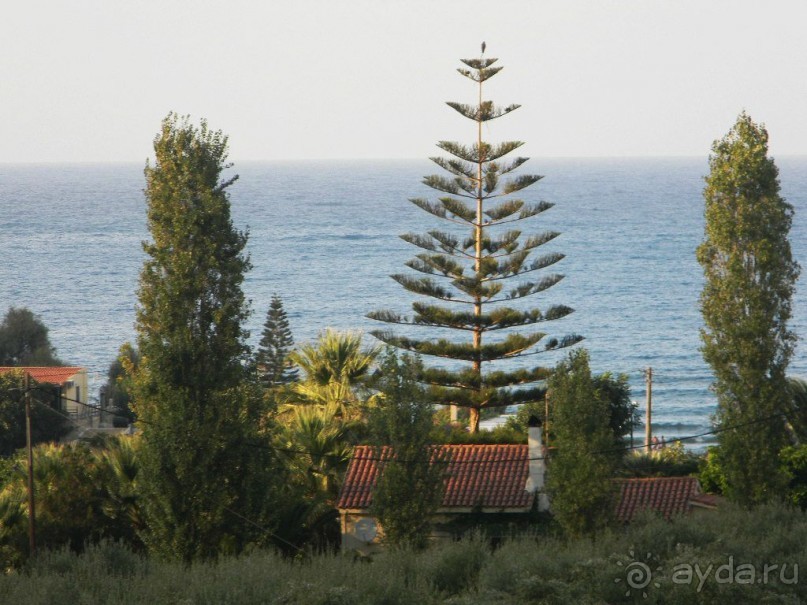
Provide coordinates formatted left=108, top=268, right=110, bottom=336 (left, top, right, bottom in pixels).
left=0, top=370, right=72, bottom=456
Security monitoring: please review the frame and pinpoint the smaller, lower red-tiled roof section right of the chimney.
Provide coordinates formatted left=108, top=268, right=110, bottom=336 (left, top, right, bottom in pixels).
left=616, top=477, right=700, bottom=522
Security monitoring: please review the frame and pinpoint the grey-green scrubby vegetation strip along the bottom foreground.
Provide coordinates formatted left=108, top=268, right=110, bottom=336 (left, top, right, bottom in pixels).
left=0, top=506, right=807, bottom=605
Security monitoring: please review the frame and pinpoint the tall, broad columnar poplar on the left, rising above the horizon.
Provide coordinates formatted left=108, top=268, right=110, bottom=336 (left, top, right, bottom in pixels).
left=134, top=114, right=274, bottom=561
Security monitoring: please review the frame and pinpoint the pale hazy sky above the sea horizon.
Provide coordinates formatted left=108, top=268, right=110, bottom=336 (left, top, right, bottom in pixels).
left=0, top=0, right=807, bottom=163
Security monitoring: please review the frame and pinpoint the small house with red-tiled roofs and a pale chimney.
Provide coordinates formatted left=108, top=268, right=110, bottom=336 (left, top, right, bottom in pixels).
left=336, top=427, right=719, bottom=552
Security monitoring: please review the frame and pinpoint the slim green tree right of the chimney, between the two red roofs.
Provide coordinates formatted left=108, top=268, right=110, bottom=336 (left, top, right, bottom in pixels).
left=547, top=349, right=614, bottom=536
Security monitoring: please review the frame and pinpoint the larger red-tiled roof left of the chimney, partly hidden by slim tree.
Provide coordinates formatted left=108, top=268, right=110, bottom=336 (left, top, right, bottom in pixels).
left=337, top=444, right=534, bottom=510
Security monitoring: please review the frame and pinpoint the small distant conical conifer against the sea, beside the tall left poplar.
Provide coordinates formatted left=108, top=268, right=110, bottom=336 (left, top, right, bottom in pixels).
left=255, top=294, right=298, bottom=387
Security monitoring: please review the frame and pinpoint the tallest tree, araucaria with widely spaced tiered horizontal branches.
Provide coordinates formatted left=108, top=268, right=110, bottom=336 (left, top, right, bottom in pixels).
left=368, top=50, right=580, bottom=432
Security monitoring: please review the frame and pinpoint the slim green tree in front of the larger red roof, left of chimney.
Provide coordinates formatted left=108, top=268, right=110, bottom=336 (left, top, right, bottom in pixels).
left=369, top=348, right=443, bottom=548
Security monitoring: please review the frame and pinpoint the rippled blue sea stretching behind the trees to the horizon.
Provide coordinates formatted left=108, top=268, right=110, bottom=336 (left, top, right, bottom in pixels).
left=0, top=157, right=807, bottom=445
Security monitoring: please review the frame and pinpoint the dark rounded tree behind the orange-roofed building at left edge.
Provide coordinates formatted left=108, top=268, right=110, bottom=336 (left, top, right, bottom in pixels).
left=0, top=307, right=62, bottom=366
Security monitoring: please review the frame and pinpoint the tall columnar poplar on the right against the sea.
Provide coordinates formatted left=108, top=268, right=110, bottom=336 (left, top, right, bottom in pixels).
left=697, top=113, right=799, bottom=504
